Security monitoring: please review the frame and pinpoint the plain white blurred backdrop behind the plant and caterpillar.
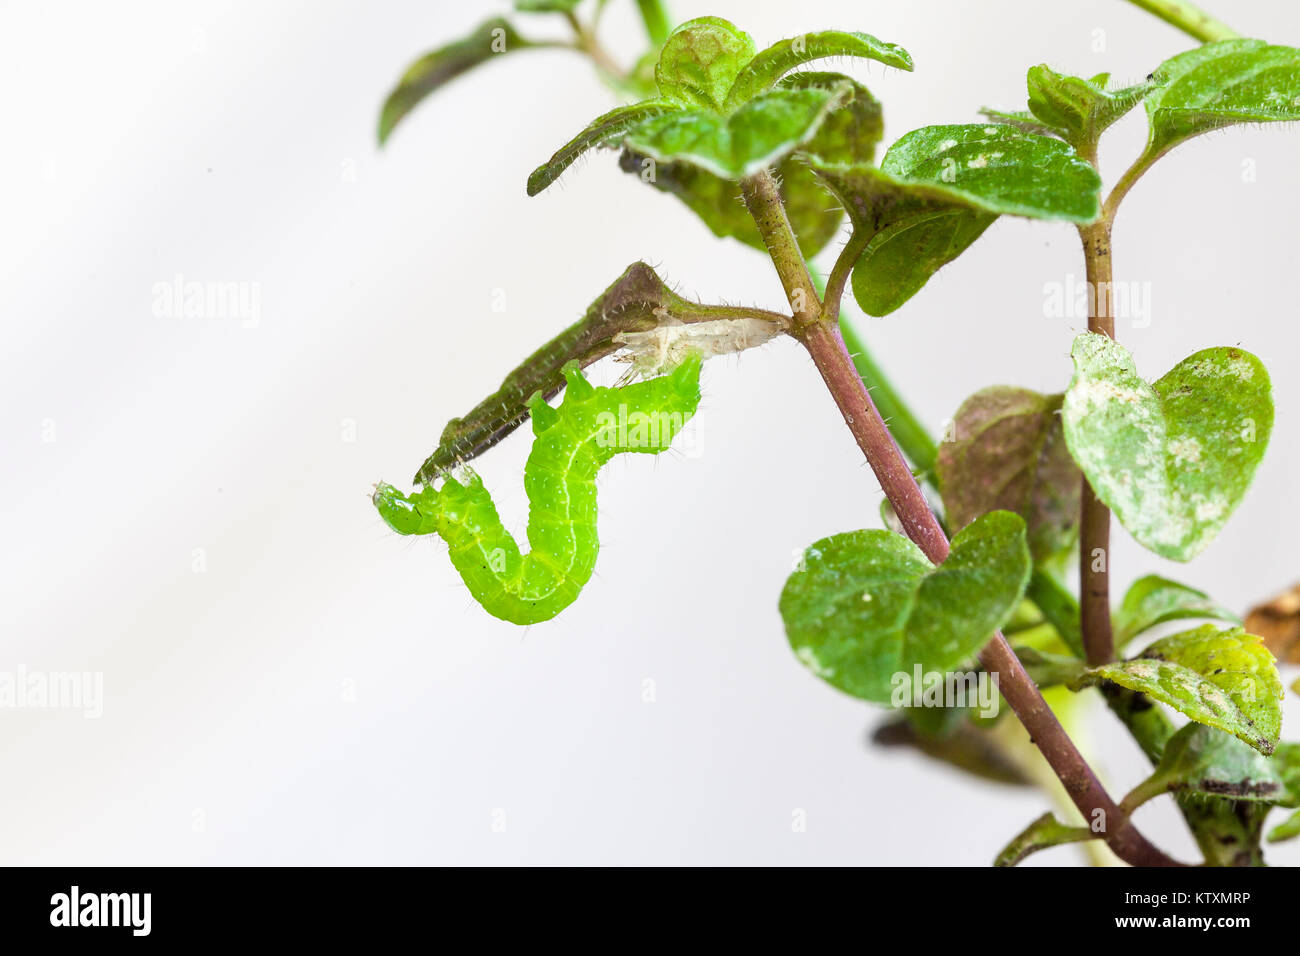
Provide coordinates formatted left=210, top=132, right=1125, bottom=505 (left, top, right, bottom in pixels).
left=0, top=0, right=1300, bottom=865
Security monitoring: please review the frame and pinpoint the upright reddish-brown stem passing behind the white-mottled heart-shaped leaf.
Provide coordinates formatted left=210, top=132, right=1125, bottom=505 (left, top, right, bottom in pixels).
left=1079, top=219, right=1115, bottom=667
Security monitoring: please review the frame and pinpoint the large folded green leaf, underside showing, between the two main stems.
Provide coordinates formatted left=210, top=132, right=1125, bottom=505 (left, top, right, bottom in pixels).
left=810, top=125, right=1101, bottom=315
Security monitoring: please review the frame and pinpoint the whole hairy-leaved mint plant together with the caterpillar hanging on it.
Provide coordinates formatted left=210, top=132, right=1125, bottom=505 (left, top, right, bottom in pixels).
left=373, top=0, right=1300, bottom=866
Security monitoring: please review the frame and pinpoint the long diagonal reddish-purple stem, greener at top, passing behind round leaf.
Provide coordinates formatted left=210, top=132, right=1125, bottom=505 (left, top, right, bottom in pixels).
left=741, top=172, right=1178, bottom=866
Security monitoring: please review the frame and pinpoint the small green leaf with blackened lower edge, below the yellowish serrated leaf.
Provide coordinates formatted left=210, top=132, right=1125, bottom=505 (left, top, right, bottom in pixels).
left=1125, top=723, right=1288, bottom=812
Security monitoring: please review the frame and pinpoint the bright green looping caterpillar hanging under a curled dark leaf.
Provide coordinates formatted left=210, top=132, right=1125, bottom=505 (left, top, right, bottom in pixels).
left=373, top=352, right=702, bottom=624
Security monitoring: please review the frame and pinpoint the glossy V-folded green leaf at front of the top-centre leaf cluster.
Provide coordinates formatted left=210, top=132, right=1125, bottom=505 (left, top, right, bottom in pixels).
left=627, top=88, right=836, bottom=179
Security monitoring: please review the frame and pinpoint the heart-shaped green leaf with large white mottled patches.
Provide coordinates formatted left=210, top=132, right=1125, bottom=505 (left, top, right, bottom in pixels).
left=1062, top=333, right=1273, bottom=561
